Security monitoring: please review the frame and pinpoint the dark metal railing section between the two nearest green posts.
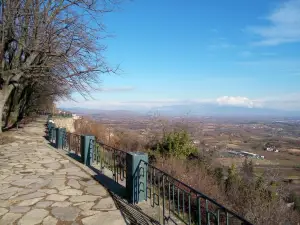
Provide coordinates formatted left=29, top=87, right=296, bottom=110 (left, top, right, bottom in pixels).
left=91, top=141, right=127, bottom=183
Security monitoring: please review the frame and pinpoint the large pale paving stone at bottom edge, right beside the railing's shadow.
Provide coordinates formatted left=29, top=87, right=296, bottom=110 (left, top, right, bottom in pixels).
left=82, top=211, right=126, bottom=225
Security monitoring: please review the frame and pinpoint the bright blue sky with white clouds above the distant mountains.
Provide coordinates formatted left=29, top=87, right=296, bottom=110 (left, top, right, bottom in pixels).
left=59, top=0, right=300, bottom=110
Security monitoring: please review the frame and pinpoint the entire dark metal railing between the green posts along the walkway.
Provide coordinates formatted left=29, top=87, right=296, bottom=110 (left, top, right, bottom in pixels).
left=49, top=116, right=251, bottom=225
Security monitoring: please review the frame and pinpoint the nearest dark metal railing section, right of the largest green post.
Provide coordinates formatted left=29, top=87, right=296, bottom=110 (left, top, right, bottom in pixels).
left=142, top=161, right=251, bottom=225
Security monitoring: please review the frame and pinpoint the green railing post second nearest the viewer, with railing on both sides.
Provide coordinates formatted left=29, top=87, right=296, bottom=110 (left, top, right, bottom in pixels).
left=80, top=135, right=95, bottom=166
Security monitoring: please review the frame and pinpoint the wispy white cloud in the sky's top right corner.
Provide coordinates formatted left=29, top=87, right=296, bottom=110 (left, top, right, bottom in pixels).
left=247, top=0, right=300, bottom=45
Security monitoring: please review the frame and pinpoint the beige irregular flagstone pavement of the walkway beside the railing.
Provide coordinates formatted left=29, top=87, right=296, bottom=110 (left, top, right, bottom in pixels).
left=0, top=119, right=126, bottom=225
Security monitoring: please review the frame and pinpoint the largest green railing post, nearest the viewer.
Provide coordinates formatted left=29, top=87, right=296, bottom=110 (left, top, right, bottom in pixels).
left=126, top=152, right=148, bottom=203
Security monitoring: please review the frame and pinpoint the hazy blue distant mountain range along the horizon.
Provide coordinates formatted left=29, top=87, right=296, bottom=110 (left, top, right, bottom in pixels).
left=64, top=103, right=300, bottom=119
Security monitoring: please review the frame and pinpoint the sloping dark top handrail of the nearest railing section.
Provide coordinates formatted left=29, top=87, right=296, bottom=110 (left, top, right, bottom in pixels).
left=141, top=160, right=252, bottom=225
